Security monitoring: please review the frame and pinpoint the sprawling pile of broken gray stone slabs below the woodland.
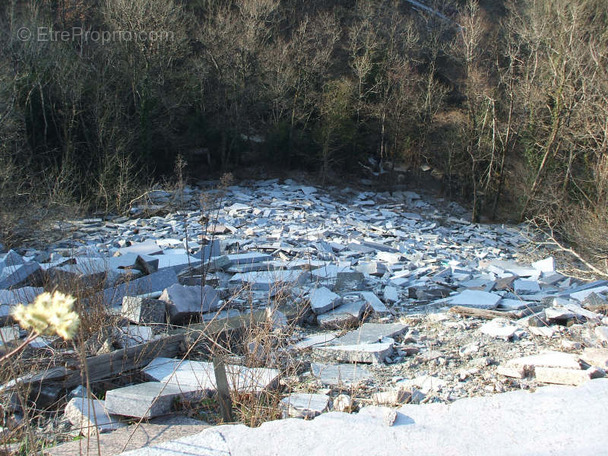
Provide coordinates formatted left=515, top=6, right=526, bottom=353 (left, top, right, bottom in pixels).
left=0, top=180, right=608, bottom=452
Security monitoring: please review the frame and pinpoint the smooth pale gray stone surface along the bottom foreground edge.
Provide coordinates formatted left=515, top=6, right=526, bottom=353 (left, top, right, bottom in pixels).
left=116, top=379, right=608, bottom=456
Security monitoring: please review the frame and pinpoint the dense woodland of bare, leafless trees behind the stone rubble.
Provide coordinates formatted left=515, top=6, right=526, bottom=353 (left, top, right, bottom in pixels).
left=0, top=0, right=608, bottom=263
